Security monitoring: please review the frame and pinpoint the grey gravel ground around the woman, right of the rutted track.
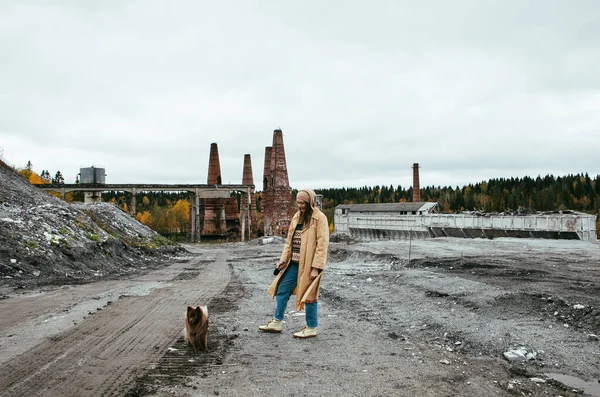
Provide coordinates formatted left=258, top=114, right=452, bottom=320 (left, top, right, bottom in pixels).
left=136, top=239, right=600, bottom=396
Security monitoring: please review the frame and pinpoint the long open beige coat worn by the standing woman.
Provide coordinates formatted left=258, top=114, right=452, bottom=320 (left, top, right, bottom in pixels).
left=267, top=191, right=329, bottom=311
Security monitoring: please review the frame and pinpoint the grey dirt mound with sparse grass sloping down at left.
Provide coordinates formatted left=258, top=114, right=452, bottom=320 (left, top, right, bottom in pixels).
left=0, top=158, right=183, bottom=288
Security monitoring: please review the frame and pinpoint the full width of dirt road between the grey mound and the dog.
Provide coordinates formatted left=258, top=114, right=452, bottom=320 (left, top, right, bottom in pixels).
left=0, top=249, right=231, bottom=396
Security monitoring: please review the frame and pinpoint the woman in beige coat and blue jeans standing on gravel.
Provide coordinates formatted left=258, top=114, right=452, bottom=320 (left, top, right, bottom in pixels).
left=258, top=189, right=329, bottom=338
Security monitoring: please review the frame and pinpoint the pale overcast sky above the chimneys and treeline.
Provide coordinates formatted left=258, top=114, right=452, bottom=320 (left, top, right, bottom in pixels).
left=0, top=0, right=600, bottom=190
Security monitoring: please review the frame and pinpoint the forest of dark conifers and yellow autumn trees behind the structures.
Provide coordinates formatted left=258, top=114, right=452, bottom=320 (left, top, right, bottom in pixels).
left=18, top=163, right=600, bottom=240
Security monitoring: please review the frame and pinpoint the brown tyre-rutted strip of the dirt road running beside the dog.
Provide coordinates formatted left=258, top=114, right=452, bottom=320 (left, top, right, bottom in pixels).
left=0, top=255, right=231, bottom=396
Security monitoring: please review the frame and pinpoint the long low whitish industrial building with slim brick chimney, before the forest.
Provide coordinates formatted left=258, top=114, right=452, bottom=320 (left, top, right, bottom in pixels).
left=334, top=163, right=597, bottom=241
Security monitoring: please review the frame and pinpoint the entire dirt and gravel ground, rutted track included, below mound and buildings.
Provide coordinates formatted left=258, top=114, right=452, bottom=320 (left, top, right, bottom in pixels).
left=0, top=239, right=600, bottom=397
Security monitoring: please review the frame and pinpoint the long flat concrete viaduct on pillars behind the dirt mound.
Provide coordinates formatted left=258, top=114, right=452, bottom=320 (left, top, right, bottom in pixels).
left=36, top=183, right=254, bottom=242
